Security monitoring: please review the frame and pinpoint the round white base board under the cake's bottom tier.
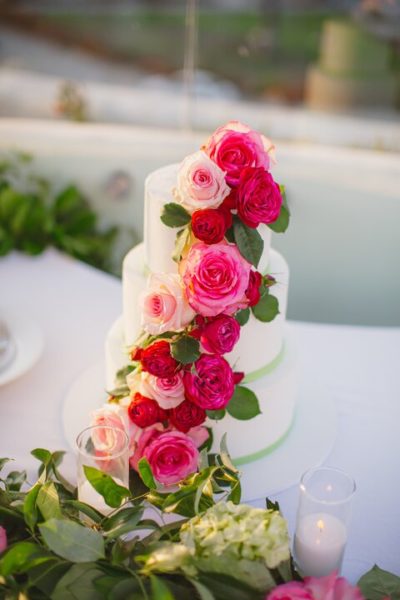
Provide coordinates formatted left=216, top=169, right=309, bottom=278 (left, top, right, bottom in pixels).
left=62, top=361, right=337, bottom=502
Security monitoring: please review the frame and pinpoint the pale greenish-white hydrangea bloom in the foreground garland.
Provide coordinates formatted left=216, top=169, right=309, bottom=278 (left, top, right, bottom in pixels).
left=180, top=502, right=290, bottom=569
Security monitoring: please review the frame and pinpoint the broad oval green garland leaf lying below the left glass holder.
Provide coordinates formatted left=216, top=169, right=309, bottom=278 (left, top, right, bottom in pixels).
left=39, top=519, right=105, bottom=563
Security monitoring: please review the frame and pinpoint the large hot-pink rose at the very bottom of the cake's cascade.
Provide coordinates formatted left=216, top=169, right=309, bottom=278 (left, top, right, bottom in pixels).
left=143, top=431, right=199, bottom=485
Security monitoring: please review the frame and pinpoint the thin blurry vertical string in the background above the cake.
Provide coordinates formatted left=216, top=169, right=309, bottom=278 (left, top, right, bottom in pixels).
left=182, top=0, right=197, bottom=131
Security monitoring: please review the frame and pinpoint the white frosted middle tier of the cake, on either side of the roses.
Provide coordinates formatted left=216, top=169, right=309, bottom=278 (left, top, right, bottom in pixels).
left=121, top=244, right=289, bottom=375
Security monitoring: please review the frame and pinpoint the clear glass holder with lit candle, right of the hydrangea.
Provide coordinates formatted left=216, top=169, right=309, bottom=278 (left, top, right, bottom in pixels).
left=293, top=467, right=356, bottom=577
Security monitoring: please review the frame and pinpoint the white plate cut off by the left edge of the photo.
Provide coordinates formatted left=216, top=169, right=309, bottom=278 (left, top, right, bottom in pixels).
left=0, top=308, right=44, bottom=385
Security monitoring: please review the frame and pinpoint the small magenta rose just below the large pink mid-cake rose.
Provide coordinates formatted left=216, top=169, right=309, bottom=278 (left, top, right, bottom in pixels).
left=200, top=315, right=240, bottom=354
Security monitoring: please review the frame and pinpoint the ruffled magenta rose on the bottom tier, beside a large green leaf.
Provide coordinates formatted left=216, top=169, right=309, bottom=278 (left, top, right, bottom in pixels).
left=183, top=354, right=235, bottom=410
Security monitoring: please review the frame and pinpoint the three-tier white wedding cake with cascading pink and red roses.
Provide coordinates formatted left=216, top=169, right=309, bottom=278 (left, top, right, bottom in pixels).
left=94, top=122, right=297, bottom=484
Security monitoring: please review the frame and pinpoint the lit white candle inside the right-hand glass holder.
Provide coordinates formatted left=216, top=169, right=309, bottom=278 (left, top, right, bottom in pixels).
left=294, top=513, right=347, bottom=577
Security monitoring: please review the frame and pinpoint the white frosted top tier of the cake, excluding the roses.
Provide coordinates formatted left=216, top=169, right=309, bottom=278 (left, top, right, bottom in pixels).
left=144, top=164, right=271, bottom=273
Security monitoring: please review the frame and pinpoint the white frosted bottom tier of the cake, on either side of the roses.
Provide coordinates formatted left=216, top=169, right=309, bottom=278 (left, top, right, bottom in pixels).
left=106, top=318, right=298, bottom=466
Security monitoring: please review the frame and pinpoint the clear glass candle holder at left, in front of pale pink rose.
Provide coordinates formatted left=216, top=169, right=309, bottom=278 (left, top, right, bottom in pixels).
left=76, top=425, right=129, bottom=515
